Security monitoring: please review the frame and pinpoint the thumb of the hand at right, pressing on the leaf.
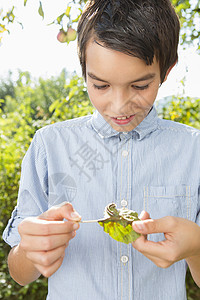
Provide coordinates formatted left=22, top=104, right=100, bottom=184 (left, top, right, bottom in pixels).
left=132, top=217, right=174, bottom=234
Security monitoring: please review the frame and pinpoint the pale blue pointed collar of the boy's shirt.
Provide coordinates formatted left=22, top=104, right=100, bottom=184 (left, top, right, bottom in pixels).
left=90, top=106, right=158, bottom=140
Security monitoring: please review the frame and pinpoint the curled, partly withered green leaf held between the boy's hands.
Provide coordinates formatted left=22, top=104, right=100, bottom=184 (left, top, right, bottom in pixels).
left=98, top=203, right=140, bottom=244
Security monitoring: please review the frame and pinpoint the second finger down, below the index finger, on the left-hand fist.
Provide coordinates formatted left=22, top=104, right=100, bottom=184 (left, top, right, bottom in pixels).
left=20, top=231, right=76, bottom=252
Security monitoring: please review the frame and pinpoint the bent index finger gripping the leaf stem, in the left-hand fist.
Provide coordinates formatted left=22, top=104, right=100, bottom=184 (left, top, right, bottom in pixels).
left=18, top=217, right=80, bottom=236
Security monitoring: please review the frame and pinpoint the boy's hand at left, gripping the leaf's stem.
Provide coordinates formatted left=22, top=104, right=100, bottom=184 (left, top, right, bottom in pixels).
left=18, top=203, right=81, bottom=277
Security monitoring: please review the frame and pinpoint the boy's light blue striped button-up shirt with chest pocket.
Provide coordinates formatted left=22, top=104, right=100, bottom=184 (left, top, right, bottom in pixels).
left=3, top=107, right=200, bottom=300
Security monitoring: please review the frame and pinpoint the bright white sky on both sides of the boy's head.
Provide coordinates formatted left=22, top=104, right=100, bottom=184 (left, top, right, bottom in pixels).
left=0, top=0, right=200, bottom=99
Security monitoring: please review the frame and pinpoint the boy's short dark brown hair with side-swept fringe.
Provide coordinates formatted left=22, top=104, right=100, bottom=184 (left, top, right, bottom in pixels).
left=77, top=0, right=180, bottom=82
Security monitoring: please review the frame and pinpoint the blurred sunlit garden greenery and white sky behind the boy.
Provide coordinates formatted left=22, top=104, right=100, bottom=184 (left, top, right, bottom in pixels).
left=0, top=0, right=200, bottom=300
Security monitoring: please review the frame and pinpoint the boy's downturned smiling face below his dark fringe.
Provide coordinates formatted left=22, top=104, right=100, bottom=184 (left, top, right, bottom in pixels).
left=86, top=41, right=160, bottom=132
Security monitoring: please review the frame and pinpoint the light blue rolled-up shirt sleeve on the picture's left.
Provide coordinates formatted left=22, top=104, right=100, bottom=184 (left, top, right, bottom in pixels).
left=3, top=131, right=48, bottom=247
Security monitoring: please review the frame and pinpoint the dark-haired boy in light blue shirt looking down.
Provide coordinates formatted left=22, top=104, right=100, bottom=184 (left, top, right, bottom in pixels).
left=4, top=0, right=200, bottom=300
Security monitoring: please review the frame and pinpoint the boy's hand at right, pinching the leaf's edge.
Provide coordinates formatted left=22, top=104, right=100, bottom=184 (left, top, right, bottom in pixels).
left=132, top=212, right=200, bottom=268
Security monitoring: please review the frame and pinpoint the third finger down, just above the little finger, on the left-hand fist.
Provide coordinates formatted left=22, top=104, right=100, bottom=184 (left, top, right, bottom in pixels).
left=26, top=245, right=67, bottom=267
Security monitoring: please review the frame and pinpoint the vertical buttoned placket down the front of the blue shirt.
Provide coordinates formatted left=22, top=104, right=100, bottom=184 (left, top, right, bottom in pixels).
left=117, top=133, right=132, bottom=300
